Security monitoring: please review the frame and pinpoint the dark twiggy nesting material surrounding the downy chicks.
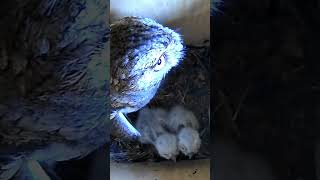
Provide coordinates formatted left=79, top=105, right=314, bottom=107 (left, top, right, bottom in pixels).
left=110, top=46, right=210, bottom=162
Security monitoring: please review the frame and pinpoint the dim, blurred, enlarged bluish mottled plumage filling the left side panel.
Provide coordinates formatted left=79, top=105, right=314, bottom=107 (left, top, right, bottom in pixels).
left=0, top=0, right=109, bottom=179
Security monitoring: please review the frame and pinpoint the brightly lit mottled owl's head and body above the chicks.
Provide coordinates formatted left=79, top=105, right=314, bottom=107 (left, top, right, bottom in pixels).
left=110, top=17, right=184, bottom=139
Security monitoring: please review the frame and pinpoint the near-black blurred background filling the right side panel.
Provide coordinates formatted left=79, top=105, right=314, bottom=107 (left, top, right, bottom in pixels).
left=211, top=0, right=320, bottom=180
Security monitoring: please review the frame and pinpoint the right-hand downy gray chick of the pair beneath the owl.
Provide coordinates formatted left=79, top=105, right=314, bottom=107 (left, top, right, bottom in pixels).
left=165, top=105, right=201, bottom=158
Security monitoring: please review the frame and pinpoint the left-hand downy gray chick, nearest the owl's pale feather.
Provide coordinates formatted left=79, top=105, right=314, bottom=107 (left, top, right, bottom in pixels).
left=136, top=108, right=179, bottom=161
